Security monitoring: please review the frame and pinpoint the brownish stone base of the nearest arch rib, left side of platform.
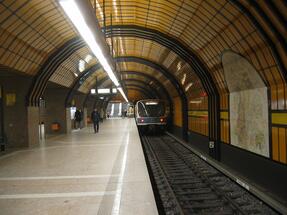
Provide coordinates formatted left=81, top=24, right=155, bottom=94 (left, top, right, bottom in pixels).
left=27, top=107, right=40, bottom=147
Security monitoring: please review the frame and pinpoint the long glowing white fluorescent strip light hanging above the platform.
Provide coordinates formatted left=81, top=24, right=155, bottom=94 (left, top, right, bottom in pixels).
left=59, top=0, right=128, bottom=101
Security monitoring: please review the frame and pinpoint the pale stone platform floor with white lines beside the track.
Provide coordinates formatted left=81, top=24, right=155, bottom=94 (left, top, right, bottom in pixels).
left=0, top=119, right=158, bottom=215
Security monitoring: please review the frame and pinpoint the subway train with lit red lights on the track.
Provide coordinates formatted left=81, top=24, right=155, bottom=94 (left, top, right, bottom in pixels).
left=135, top=99, right=168, bottom=133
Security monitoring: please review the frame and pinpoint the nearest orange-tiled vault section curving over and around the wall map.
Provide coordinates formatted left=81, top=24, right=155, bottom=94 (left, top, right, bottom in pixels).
left=98, top=0, right=287, bottom=109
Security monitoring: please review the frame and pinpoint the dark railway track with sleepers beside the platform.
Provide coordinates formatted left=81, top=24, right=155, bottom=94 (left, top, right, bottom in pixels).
left=142, top=135, right=278, bottom=215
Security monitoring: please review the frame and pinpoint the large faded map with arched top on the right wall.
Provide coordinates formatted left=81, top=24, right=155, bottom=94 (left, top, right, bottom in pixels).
left=222, top=51, right=269, bottom=157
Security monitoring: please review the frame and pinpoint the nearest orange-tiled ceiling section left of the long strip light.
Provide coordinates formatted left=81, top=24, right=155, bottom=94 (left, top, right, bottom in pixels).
left=0, top=0, right=77, bottom=75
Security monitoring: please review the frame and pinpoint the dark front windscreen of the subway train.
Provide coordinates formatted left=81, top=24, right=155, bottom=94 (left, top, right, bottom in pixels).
left=138, top=101, right=165, bottom=117
